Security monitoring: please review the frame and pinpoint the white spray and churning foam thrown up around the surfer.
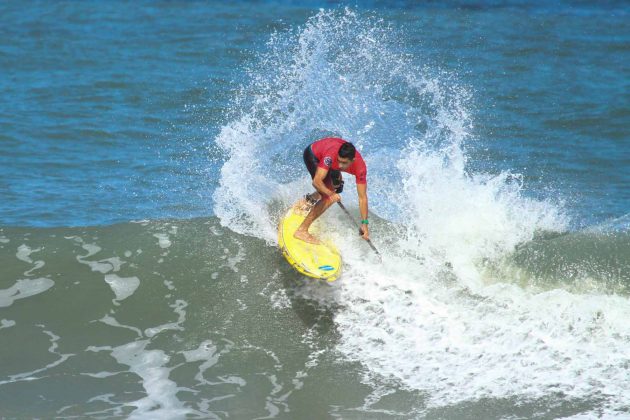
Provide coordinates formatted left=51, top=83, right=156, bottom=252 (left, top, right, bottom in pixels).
left=214, top=10, right=630, bottom=416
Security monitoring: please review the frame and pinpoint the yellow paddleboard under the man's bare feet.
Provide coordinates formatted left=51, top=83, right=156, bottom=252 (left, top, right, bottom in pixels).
left=278, top=200, right=341, bottom=282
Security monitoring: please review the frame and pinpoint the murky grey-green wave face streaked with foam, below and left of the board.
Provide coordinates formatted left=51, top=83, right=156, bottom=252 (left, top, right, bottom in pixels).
left=0, top=218, right=627, bottom=419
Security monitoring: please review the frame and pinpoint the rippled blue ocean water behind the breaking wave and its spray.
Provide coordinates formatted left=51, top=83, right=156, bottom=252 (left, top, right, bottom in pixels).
left=0, top=2, right=630, bottom=226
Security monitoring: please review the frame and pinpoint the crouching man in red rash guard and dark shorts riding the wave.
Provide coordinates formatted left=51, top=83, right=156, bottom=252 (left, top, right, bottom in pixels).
left=293, top=137, right=370, bottom=244
